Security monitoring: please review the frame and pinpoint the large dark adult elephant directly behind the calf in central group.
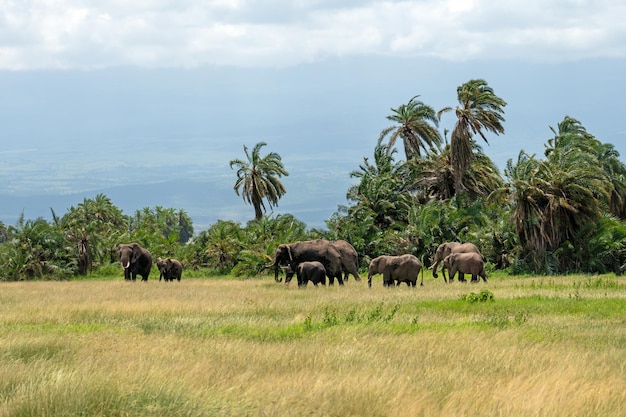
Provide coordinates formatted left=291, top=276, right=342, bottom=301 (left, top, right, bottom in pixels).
left=267, top=239, right=343, bottom=285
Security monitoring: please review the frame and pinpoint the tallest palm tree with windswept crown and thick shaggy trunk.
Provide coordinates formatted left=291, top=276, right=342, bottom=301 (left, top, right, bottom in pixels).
left=440, top=79, right=506, bottom=192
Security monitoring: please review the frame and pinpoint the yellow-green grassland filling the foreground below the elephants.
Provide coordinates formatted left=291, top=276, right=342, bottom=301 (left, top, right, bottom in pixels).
left=0, top=276, right=626, bottom=417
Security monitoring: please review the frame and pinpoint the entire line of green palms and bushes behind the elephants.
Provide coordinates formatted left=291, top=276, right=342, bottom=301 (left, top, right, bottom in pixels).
left=0, top=80, right=626, bottom=280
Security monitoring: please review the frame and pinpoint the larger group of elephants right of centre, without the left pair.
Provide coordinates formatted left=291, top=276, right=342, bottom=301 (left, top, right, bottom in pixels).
left=267, top=239, right=487, bottom=287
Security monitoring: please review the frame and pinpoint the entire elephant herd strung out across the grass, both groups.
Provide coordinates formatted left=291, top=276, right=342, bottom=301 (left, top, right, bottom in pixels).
left=117, top=239, right=487, bottom=287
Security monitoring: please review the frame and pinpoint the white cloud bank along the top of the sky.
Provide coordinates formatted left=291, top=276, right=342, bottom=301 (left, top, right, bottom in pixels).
left=0, top=0, right=626, bottom=70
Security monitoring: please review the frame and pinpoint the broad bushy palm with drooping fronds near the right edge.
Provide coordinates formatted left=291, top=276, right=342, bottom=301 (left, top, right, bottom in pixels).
left=493, top=139, right=607, bottom=273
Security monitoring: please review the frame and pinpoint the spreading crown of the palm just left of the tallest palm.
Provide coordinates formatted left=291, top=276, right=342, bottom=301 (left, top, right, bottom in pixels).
left=379, top=96, right=442, bottom=161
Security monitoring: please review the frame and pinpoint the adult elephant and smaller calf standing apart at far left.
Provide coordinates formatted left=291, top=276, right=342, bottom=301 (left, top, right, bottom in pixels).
left=117, top=243, right=183, bottom=282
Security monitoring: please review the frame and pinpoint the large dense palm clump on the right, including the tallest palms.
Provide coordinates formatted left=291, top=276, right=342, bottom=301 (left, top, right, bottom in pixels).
left=327, top=80, right=626, bottom=273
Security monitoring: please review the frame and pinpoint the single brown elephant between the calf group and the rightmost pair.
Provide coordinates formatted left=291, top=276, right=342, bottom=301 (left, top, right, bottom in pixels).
left=367, top=254, right=424, bottom=287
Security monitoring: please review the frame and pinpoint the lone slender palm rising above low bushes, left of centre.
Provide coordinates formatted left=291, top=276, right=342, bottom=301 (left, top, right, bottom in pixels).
left=230, top=142, right=289, bottom=220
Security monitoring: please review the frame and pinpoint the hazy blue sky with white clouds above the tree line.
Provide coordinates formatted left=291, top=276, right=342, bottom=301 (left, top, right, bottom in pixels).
left=0, top=0, right=626, bottom=225
